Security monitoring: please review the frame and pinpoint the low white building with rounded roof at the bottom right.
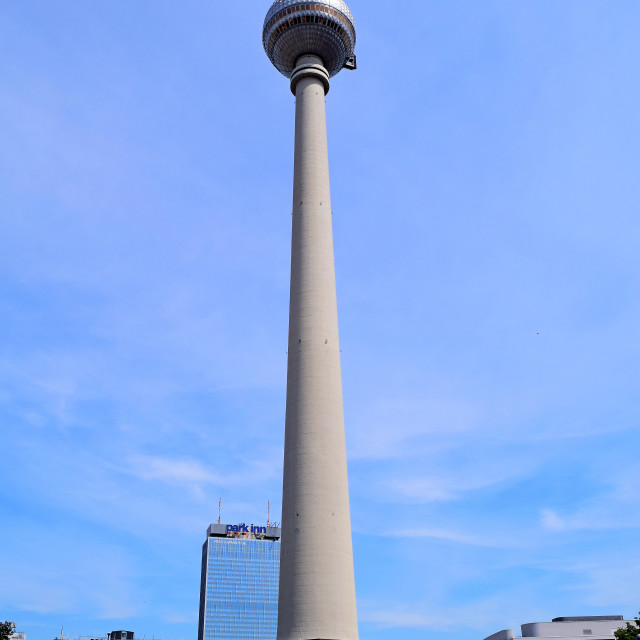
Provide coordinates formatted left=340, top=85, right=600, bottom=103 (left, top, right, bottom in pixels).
left=485, top=616, right=640, bottom=640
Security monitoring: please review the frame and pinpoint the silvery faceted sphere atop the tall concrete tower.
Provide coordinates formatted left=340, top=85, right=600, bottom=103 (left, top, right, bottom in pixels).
left=262, top=0, right=356, bottom=78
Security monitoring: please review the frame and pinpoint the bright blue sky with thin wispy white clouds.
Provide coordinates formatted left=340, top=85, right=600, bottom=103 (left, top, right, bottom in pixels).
left=0, top=0, right=640, bottom=640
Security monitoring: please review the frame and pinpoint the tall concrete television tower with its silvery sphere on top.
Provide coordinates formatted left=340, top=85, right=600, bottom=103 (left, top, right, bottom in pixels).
left=262, top=0, right=358, bottom=640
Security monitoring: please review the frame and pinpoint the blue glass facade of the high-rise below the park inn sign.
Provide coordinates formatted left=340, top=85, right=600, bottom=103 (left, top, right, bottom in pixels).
left=198, top=537, right=280, bottom=640
